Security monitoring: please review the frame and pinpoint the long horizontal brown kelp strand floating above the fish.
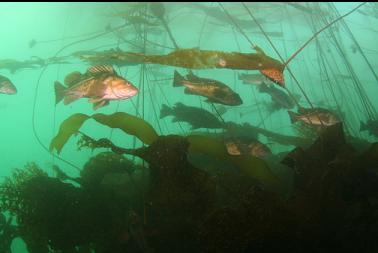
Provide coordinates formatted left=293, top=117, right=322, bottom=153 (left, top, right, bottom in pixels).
left=75, top=47, right=285, bottom=86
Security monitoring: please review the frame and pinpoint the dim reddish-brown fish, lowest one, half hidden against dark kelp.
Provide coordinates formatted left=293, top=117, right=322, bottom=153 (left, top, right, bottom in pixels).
left=224, top=137, right=272, bottom=158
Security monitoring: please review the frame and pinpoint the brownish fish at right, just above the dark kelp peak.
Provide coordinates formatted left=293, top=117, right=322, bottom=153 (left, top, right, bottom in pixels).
left=288, top=107, right=340, bottom=126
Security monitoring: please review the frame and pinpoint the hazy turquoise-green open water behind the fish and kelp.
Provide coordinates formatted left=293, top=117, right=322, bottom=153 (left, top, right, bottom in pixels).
left=0, top=3, right=378, bottom=252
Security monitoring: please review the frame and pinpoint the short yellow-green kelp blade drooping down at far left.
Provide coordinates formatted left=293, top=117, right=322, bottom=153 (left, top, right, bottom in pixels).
left=49, top=113, right=90, bottom=154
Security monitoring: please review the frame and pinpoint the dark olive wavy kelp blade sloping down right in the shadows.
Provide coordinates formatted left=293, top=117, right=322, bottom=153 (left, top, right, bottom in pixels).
left=187, top=135, right=280, bottom=190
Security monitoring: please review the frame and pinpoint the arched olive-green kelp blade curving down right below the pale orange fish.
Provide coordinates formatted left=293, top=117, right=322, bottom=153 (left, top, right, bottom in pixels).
left=92, top=112, right=158, bottom=145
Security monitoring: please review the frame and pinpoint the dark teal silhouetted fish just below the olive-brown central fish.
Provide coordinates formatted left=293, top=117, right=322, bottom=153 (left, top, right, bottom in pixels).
left=160, top=103, right=223, bottom=130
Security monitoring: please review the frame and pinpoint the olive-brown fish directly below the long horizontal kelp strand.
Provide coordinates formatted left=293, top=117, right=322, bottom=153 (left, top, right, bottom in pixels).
left=173, top=71, right=243, bottom=106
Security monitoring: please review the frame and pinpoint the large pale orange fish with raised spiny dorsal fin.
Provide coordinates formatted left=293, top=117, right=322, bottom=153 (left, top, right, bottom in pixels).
left=55, top=65, right=138, bottom=110
